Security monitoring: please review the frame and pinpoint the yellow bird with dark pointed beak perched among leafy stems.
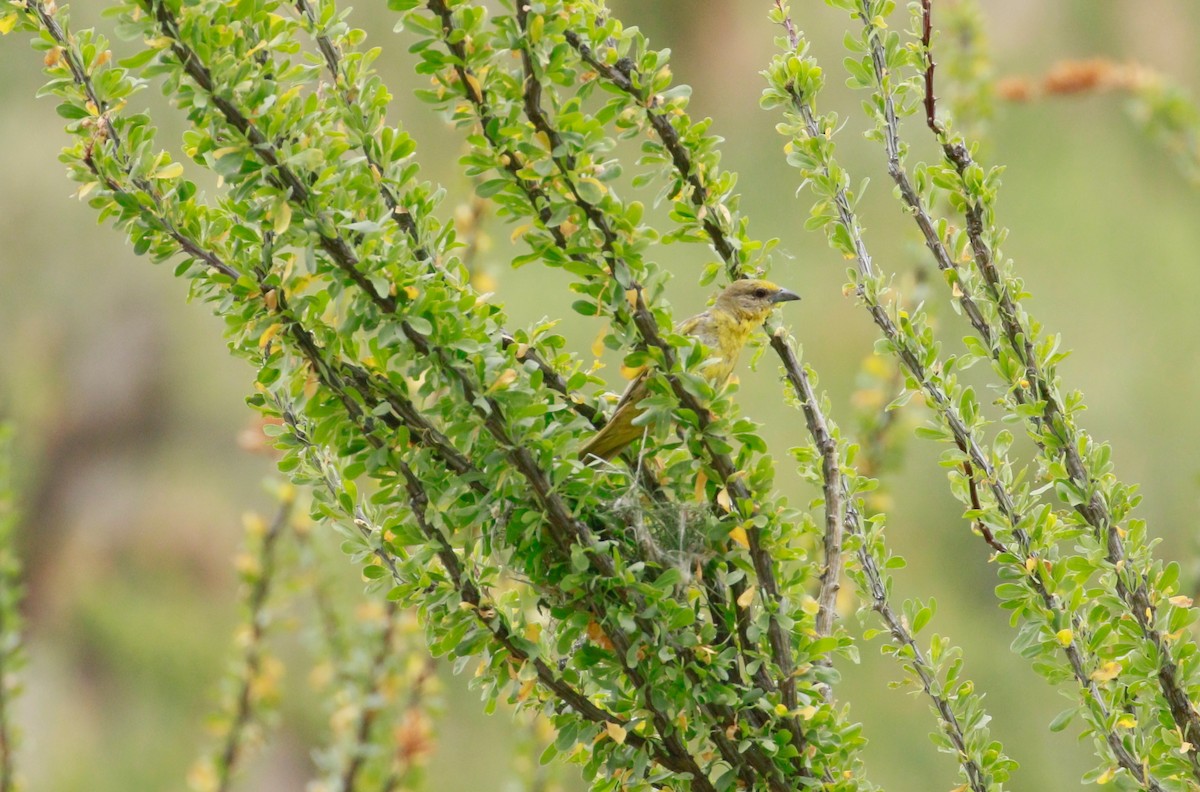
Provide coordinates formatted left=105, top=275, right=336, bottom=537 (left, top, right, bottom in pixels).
left=580, top=281, right=800, bottom=460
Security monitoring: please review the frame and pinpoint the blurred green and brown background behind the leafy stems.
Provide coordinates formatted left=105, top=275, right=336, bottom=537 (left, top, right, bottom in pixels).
left=0, top=0, right=1200, bottom=792
